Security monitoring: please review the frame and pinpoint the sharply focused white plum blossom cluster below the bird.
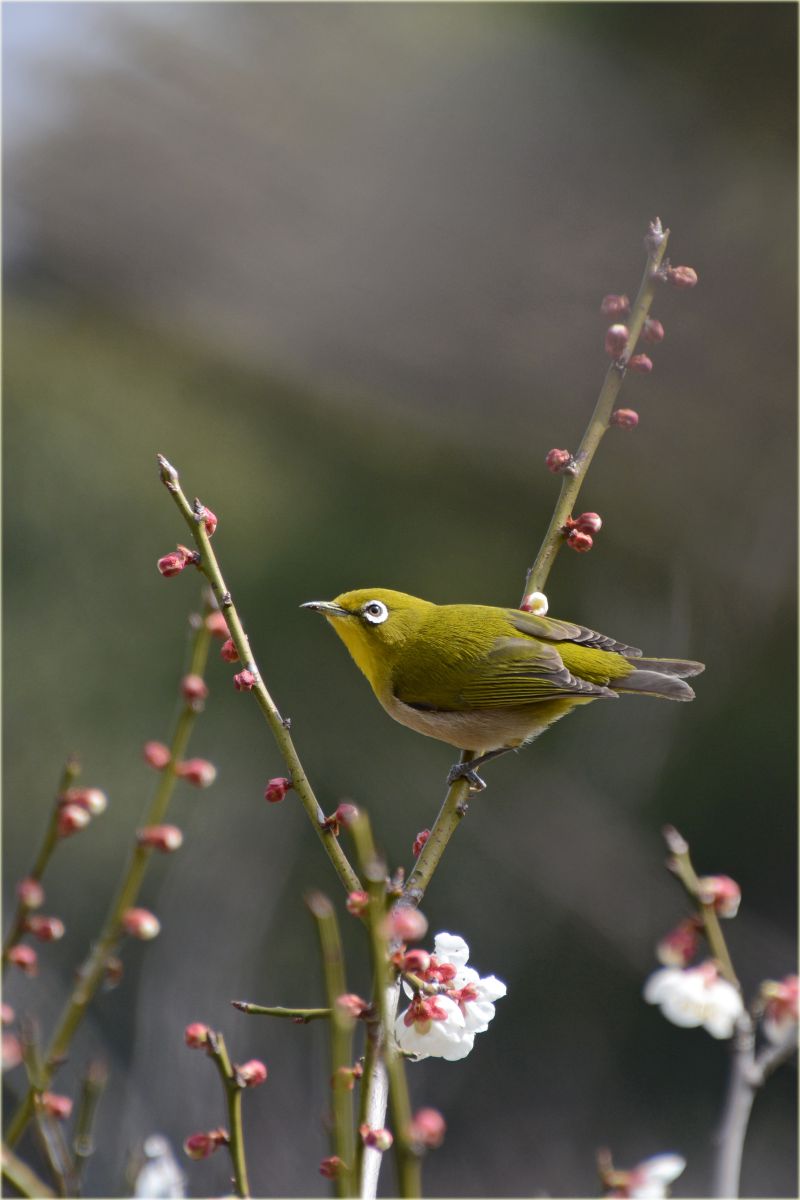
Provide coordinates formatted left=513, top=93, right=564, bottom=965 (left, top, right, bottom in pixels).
left=395, top=934, right=506, bottom=1062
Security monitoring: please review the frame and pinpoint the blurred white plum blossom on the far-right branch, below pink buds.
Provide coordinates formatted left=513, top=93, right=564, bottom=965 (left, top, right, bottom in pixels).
left=644, top=961, right=744, bottom=1038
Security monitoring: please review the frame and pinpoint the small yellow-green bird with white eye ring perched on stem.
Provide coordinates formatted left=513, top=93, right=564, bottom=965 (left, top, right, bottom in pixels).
left=301, top=588, right=704, bottom=790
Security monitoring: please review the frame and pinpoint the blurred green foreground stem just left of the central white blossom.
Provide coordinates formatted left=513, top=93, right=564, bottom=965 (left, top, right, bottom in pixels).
left=350, top=811, right=422, bottom=1198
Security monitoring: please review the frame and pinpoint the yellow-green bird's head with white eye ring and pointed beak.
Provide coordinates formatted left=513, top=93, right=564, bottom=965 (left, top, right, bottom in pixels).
left=301, top=588, right=434, bottom=691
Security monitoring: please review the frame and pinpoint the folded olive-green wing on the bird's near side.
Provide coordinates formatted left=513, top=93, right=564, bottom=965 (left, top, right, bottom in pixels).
left=392, top=637, right=614, bottom=712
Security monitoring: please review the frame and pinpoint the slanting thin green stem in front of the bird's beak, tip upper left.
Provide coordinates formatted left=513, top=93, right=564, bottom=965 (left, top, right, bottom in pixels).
left=158, top=455, right=361, bottom=892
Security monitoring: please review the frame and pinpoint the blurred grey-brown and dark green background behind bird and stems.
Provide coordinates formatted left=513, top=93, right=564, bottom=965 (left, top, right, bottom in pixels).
left=2, top=2, right=796, bottom=1196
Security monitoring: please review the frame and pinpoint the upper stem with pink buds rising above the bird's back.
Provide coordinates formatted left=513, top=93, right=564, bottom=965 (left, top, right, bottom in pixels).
left=523, top=221, right=669, bottom=600
